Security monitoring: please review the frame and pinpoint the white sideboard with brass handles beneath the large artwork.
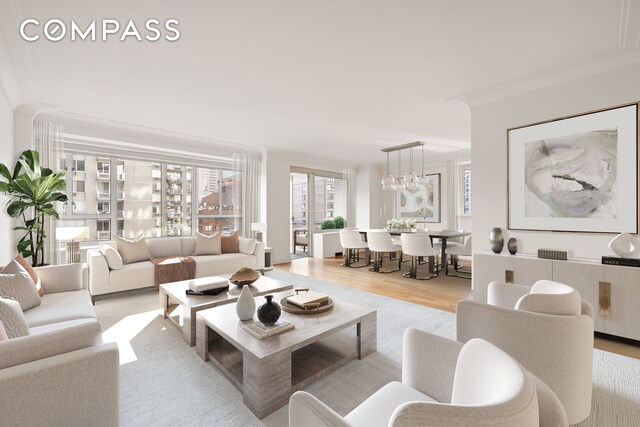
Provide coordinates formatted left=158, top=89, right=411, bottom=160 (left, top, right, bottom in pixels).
left=472, top=251, right=640, bottom=340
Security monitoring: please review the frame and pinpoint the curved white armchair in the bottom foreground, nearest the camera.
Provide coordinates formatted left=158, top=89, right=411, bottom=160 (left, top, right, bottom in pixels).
left=289, top=329, right=544, bottom=427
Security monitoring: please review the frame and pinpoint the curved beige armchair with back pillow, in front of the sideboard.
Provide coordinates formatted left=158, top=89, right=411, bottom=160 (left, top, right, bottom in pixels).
left=456, top=280, right=594, bottom=424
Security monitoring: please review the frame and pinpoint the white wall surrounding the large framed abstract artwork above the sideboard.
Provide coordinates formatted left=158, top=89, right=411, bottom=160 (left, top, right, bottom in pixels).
left=471, top=64, right=640, bottom=258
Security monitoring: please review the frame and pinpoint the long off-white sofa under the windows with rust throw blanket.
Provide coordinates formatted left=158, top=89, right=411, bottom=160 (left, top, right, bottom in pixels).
left=87, top=236, right=264, bottom=301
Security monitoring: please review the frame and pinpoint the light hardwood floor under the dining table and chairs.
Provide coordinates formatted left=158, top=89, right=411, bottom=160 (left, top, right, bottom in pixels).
left=275, top=254, right=640, bottom=359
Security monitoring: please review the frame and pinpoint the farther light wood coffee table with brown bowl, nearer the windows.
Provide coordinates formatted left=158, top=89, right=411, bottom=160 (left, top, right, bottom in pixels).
left=159, top=275, right=292, bottom=346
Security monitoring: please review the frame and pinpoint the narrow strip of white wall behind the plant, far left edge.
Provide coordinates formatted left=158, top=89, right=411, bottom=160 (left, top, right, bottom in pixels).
left=0, top=90, right=15, bottom=266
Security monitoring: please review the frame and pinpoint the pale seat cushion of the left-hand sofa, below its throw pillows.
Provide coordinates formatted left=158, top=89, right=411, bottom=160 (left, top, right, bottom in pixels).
left=25, top=290, right=95, bottom=328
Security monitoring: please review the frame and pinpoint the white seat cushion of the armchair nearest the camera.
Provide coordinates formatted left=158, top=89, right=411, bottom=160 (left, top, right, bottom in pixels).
left=344, top=381, right=435, bottom=427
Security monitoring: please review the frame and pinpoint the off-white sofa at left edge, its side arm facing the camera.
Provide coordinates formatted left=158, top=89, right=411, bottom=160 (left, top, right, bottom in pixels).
left=0, top=264, right=120, bottom=426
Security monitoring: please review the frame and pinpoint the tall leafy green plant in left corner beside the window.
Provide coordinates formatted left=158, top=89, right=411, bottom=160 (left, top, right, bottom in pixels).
left=0, top=150, right=67, bottom=267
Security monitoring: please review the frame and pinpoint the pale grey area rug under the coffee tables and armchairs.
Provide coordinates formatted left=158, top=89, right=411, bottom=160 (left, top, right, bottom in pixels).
left=95, top=270, right=640, bottom=426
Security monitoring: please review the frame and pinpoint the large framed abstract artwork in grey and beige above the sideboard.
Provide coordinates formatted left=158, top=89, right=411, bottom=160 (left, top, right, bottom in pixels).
left=507, top=104, right=638, bottom=233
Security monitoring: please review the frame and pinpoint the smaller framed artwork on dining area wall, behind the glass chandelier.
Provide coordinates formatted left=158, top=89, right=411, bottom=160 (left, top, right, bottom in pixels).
left=397, top=173, right=441, bottom=223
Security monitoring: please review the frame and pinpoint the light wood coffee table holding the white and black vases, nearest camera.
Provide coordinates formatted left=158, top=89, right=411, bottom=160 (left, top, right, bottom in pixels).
left=196, top=292, right=377, bottom=418
